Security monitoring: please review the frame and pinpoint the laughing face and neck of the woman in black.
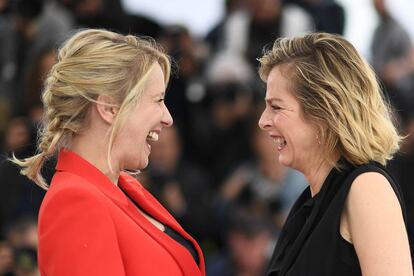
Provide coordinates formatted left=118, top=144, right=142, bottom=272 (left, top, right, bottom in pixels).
left=259, top=66, right=331, bottom=195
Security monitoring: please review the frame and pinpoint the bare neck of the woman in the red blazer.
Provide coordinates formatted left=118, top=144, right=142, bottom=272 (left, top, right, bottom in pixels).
left=68, top=136, right=120, bottom=186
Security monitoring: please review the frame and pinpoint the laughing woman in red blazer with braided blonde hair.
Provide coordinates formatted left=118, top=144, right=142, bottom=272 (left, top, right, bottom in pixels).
left=13, top=30, right=205, bottom=276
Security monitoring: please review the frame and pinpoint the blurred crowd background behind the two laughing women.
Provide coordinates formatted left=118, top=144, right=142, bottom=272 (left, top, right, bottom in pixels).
left=0, top=0, right=414, bottom=276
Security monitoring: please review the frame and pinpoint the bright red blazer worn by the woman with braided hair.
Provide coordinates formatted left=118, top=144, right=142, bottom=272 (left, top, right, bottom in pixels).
left=38, top=150, right=205, bottom=276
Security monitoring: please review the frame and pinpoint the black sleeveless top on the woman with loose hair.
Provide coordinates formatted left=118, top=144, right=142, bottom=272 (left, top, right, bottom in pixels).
left=266, top=159, right=406, bottom=276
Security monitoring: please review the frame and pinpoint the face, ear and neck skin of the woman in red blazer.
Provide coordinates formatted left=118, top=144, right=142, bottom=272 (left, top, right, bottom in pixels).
left=70, top=64, right=173, bottom=184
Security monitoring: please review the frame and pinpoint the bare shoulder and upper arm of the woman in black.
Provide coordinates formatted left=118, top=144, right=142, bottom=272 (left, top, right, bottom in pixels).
left=344, top=172, right=412, bottom=275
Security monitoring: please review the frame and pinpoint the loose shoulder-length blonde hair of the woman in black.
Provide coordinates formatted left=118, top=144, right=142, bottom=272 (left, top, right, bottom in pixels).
left=258, top=33, right=402, bottom=167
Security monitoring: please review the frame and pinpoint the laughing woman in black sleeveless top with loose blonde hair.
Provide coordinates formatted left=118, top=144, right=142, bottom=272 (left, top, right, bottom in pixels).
left=259, top=33, right=413, bottom=276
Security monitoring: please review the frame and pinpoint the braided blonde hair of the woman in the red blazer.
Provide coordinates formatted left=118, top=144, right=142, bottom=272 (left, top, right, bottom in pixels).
left=11, top=29, right=171, bottom=189
